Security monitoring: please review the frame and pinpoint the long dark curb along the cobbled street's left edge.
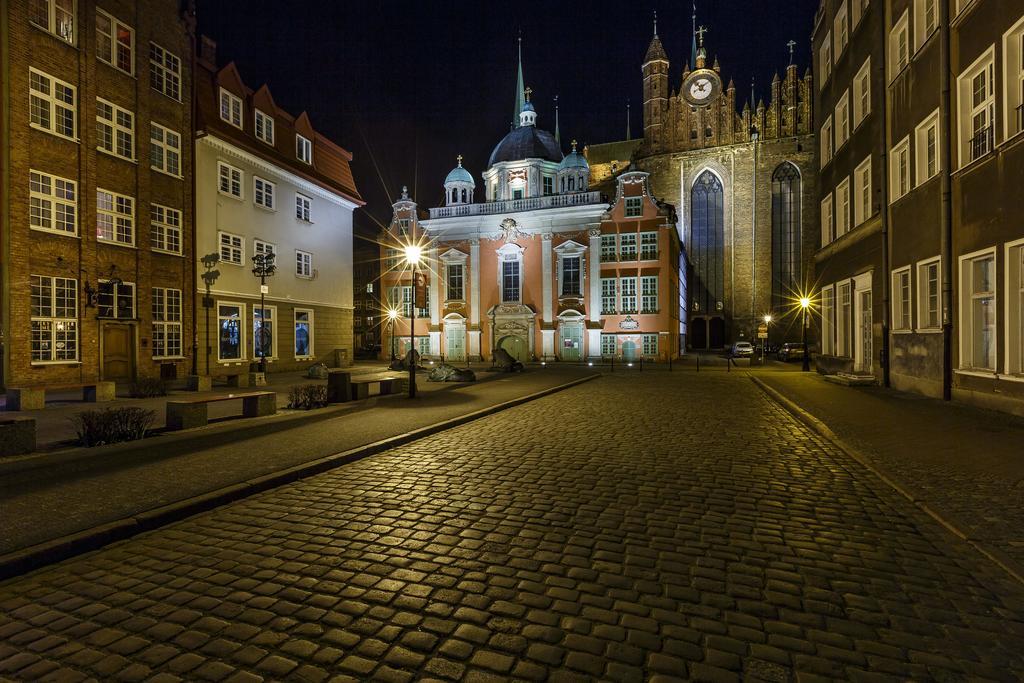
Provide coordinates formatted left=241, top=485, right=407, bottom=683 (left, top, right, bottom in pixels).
left=0, top=374, right=601, bottom=581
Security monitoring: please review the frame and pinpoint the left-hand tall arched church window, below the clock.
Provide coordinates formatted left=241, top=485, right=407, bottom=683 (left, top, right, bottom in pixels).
left=687, top=171, right=725, bottom=315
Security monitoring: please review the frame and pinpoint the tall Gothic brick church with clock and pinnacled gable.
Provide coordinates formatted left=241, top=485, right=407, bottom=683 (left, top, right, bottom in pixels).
left=587, top=24, right=817, bottom=349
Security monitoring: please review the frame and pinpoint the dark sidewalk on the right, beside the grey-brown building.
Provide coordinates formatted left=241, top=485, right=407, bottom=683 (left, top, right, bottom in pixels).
left=751, top=369, right=1024, bottom=567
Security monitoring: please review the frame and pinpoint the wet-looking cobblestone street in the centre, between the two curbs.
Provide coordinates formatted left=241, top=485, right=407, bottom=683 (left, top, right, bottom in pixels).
left=0, top=373, right=1024, bottom=681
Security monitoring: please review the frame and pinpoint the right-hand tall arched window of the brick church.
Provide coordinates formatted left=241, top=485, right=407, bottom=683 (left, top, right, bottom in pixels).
left=771, top=162, right=803, bottom=310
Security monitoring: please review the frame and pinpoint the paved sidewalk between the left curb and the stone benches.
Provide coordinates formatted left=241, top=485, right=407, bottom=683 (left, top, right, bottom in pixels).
left=0, top=367, right=595, bottom=555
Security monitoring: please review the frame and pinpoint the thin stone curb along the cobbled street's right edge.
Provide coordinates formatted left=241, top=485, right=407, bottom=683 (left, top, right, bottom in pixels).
left=750, top=376, right=1024, bottom=586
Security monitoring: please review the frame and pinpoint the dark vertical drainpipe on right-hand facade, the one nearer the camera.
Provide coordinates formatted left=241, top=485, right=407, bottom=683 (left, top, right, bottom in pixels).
left=939, top=2, right=953, bottom=400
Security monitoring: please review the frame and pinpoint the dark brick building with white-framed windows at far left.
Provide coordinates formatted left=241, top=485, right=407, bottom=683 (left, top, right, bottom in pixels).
left=0, top=0, right=194, bottom=386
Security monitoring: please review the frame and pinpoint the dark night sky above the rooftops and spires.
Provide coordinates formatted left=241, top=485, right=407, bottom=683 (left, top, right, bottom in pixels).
left=199, top=0, right=817, bottom=235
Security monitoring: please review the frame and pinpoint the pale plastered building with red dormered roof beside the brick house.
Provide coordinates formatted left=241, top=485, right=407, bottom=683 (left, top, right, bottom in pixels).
left=194, top=37, right=364, bottom=376
